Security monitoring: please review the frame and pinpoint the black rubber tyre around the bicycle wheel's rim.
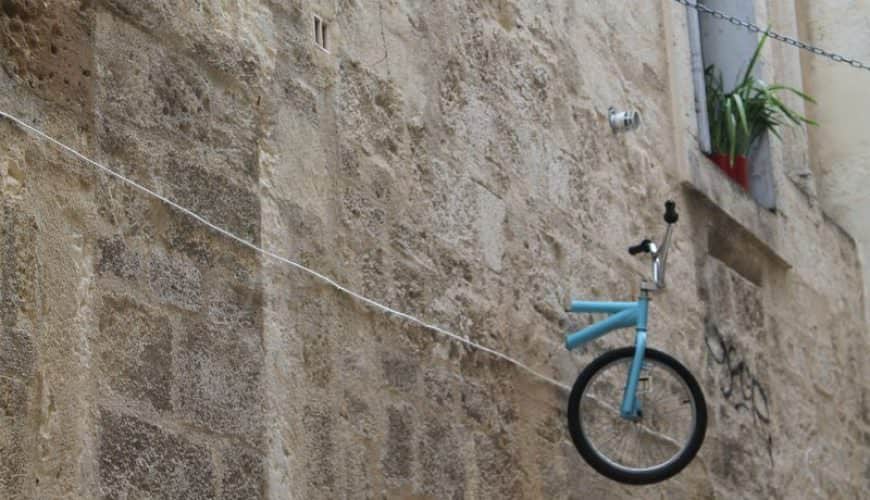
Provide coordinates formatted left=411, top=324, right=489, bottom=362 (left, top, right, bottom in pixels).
left=568, top=347, right=707, bottom=484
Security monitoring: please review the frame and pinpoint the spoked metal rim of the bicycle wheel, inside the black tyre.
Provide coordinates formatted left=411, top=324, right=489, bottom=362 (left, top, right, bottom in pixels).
left=578, top=357, right=698, bottom=473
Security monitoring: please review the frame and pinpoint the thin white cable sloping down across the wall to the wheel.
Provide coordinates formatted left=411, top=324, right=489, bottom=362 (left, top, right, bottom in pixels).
left=0, top=111, right=571, bottom=391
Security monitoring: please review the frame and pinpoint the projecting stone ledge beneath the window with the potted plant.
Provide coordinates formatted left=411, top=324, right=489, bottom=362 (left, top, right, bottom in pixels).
left=681, top=151, right=792, bottom=268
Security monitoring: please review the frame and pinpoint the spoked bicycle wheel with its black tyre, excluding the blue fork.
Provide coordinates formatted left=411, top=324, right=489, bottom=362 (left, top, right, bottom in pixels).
left=568, top=347, right=707, bottom=484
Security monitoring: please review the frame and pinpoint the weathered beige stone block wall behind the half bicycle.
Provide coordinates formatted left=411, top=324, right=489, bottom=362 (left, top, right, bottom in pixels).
left=0, top=0, right=870, bottom=499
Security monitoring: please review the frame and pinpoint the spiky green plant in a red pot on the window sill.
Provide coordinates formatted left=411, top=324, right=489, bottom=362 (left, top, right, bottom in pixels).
left=704, top=34, right=817, bottom=189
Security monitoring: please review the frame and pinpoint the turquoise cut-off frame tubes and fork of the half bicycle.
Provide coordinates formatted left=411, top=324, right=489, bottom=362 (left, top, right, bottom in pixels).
left=565, top=293, right=649, bottom=420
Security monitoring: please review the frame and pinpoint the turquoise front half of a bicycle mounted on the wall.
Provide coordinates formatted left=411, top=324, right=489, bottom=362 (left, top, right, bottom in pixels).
left=565, top=201, right=707, bottom=484
